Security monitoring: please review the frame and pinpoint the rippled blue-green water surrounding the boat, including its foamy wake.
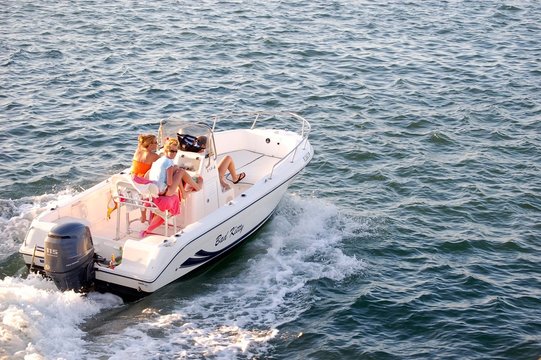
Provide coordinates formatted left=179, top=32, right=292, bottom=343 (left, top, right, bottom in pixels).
left=0, top=0, right=541, bottom=359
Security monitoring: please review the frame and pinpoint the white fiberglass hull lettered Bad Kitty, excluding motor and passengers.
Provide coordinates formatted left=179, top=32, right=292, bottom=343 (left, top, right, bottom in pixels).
left=20, top=115, right=313, bottom=297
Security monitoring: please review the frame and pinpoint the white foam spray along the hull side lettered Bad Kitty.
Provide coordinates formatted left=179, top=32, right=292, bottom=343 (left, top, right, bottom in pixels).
left=88, top=196, right=365, bottom=359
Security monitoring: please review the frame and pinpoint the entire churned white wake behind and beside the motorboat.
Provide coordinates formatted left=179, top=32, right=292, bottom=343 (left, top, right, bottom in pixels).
left=0, top=194, right=366, bottom=359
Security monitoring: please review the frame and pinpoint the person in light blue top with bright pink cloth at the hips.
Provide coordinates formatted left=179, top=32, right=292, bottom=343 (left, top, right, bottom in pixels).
left=141, top=138, right=203, bottom=237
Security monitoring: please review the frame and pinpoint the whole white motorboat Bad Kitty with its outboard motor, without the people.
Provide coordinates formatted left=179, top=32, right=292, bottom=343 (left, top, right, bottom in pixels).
left=19, top=113, right=313, bottom=298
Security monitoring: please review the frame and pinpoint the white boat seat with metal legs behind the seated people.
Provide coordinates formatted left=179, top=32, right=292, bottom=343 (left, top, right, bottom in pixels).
left=111, top=174, right=177, bottom=240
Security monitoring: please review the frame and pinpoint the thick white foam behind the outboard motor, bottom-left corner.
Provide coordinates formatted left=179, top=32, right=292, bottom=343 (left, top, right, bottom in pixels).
left=0, top=274, right=122, bottom=359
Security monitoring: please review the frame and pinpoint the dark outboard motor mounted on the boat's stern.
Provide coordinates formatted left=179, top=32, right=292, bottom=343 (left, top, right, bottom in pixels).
left=44, top=222, right=95, bottom=291
